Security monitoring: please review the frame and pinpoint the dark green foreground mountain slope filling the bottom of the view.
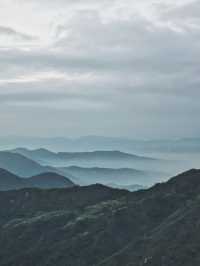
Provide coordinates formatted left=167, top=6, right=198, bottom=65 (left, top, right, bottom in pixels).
left=0, top=170, right=200, bottom=266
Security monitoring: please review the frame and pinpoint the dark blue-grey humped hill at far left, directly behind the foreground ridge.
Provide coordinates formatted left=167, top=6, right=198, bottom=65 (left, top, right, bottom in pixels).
left=0, top=168, right=74, bottom=191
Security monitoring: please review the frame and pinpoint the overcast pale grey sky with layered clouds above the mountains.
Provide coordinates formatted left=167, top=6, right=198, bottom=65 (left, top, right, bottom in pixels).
left=0, top=0, right=200, bottom=138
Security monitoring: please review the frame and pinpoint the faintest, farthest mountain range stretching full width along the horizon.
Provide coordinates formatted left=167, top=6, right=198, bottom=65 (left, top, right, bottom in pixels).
left=0, top=136, right=200, bottom=154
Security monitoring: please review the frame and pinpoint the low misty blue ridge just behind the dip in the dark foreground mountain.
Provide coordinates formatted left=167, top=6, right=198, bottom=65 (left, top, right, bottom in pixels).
left=59, top=166, right=162, bottom=186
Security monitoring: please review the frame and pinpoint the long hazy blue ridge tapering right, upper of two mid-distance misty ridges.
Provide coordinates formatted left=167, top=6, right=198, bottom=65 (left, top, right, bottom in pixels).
left=10, top=148, right=164, bottom=168
